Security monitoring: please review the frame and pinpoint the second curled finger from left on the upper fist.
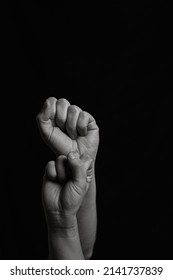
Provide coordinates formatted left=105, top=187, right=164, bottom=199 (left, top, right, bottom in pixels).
left=56, top=98, right=70, bottom=131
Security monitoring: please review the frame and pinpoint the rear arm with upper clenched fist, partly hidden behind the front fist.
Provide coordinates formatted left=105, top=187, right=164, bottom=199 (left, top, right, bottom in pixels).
left=37, top=97, right=99, bottom=259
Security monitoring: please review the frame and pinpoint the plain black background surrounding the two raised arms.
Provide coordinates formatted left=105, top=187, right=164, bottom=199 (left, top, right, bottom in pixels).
left=1, top=1, right=173, bottom=259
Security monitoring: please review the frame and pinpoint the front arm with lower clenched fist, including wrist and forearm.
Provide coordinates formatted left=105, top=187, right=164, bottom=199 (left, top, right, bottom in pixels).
left=42, top=153, right=92, bottom=259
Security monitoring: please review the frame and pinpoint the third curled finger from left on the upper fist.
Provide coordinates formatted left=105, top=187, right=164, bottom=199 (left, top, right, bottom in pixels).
left=66, top=105, right=81, bottom=140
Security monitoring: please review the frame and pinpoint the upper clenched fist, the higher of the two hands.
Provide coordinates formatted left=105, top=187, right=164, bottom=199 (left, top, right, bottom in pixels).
left=37, top=97, right=99, bottom=160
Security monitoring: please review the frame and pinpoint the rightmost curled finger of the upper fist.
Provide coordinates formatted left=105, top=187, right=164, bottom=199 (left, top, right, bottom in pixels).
left=77, top=111, right=97, bottom=136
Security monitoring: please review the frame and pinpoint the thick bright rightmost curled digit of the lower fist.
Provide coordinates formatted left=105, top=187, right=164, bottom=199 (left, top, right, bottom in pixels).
left=67, top=152, right=93, bottom=188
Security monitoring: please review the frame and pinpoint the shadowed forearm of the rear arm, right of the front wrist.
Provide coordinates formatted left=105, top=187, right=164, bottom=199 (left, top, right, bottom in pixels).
left=77, top=164, right=97, bottom=259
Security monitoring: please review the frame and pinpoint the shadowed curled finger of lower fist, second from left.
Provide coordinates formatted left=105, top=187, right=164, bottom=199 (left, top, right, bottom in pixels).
left=55, top=155, right=68, bottom=184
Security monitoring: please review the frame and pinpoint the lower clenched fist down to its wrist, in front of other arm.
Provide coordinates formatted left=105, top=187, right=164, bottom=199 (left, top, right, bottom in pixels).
left=42, top=152, right=93, bottom=228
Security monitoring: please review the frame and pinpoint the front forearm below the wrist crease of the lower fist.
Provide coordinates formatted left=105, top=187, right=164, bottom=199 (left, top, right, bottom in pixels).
left=48, top=217, right=84, bottom=260
